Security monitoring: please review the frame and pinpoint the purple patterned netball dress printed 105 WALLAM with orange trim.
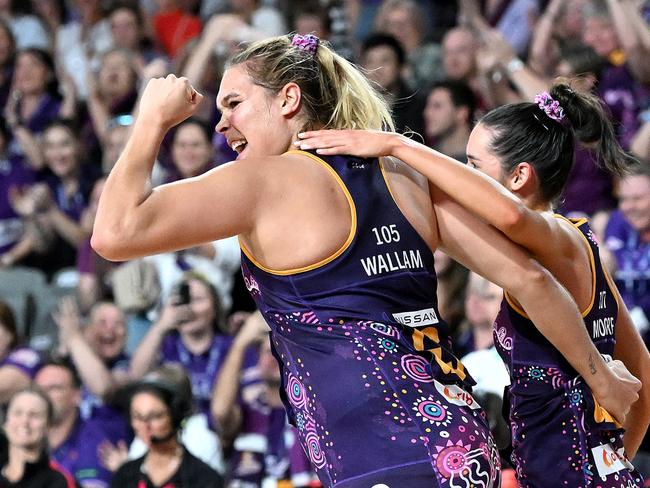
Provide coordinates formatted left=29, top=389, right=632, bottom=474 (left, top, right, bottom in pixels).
left=242, top=151, right=500, bottom=488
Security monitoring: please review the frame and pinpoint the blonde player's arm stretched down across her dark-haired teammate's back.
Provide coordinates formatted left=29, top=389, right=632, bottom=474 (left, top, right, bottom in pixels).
left=431, top=187, right=640, bottom=423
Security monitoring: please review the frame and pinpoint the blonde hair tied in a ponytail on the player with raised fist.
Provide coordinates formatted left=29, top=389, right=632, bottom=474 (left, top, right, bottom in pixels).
left=228, top=36, right=395, bottom=130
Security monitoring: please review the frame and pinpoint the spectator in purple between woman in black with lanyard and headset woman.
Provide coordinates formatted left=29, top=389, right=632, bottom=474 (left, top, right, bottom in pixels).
left=34, top=359, right=112, bottom=488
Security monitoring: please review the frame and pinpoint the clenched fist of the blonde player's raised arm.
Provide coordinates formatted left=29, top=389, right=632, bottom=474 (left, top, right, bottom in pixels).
left=138, top=75, right=203, bottom=129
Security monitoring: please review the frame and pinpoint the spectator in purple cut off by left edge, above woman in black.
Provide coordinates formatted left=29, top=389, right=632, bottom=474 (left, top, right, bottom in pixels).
left=0, top=301, right=41, bottom=405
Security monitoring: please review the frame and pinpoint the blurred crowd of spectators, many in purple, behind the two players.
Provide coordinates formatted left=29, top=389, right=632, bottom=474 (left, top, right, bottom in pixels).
left=0, top=0, right=650, bottom=488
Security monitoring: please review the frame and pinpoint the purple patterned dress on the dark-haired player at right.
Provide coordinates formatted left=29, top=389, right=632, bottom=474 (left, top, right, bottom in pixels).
left=494, top=216, right=643, bottom=488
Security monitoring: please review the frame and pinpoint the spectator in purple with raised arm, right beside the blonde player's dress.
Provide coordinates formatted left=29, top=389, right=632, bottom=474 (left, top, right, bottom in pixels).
left=211, top=312, right=320, bottom=488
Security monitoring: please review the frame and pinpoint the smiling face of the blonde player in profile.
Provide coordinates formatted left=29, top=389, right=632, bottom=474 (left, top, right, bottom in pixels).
left=216, top=64, right=294, bottom=159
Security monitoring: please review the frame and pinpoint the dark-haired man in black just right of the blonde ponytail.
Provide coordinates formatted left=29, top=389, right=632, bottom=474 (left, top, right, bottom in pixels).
left=361, top=34, right=424, bottom=134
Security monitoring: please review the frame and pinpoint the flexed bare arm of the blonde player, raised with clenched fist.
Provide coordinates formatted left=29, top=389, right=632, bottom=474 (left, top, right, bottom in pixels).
left=91, top=75, right=261, bottom=260
